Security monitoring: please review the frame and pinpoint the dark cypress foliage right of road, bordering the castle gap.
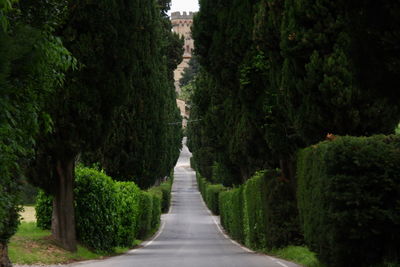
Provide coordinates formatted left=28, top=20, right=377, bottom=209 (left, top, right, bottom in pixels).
left=188, top=0, right=277, bottom=186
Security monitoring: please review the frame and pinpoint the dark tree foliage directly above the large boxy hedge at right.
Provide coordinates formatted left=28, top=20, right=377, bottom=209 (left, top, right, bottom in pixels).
left=281, top=0, right=400, bottom=149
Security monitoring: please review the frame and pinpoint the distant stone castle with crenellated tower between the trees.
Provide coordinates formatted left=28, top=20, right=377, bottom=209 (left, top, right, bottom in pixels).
left=171, top=12, right=194, bottom=128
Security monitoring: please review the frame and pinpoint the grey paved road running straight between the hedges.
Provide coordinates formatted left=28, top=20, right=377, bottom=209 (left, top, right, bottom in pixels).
left=74, top=140, right=299, bottom=267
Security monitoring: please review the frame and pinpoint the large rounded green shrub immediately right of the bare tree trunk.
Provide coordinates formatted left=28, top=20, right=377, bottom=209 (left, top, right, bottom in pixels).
left=74, top=167, right=122, bottom=251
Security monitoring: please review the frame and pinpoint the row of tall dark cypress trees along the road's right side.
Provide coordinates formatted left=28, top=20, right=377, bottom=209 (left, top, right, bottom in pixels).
left=188, top=0, right=400, bottom=183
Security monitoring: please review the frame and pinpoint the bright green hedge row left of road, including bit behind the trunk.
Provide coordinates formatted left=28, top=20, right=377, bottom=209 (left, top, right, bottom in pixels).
left=36, top=167, right=172, bottom=251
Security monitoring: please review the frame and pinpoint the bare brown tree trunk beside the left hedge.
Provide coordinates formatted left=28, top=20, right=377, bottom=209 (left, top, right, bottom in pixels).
left=51, top=158, right=77, bottom=252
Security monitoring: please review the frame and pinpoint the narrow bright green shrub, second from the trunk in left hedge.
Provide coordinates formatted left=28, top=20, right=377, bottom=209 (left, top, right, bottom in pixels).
left=115, top=182, right=140, bottom=247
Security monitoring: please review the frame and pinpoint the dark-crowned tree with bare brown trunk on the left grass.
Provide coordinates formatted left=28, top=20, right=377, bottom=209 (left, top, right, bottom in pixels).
left=31, top=0, right=153, bottom=251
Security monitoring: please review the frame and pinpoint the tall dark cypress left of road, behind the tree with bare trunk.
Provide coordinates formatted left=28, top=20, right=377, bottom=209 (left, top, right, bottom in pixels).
left=85, top=2, right=183, bottom=188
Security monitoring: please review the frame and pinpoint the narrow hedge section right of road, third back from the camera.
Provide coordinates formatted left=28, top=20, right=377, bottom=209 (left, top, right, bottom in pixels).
left=219, top=186, right=245, bottom=244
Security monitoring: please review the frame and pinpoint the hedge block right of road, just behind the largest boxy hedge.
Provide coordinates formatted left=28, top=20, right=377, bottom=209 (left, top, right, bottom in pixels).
left=243, top=170, right=301, bottom=249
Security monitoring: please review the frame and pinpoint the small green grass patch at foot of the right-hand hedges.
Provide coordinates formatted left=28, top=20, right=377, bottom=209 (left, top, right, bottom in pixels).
left=264, top=246, right=323, bottom=267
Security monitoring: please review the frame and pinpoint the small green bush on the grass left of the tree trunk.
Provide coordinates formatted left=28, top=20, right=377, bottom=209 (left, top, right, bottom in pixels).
left=35, top=190, right=53, bottom=230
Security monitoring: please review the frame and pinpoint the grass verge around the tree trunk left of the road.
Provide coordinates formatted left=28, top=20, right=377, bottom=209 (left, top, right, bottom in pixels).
left=9, top=222, right=141, bottom=265
